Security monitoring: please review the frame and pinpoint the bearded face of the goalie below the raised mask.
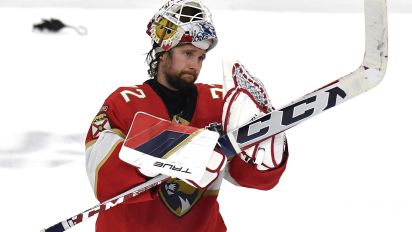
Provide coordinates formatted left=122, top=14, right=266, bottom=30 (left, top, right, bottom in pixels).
left=157, top=44, right=206, bottom=90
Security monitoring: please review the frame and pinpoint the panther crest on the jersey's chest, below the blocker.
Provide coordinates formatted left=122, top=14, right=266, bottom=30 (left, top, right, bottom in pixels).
left=159, top=179, right=205, bottom=217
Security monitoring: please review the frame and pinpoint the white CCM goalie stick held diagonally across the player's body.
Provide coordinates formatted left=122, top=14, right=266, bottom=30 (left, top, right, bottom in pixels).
left=41, top=0, right=388, bottom=232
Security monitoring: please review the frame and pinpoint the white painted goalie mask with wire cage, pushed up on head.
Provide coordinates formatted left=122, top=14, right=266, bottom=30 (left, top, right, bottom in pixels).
left=146, top=0, right=217, bottom=53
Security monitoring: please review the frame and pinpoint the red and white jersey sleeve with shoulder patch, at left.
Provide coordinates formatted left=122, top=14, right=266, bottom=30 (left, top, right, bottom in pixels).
left=86, top=88, right=156, bottom=202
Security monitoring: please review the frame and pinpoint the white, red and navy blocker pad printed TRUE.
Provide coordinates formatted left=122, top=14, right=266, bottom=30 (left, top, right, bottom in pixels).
left=119, top=112, right=219, bottom=181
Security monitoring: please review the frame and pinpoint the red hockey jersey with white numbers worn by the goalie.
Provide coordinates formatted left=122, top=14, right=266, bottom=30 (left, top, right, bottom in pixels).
left=86, top=83, right=286, bottom=232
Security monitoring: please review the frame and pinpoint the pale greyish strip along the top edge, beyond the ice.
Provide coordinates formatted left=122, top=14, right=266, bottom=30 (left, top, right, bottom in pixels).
left=0, top=0, right=412, bottom=12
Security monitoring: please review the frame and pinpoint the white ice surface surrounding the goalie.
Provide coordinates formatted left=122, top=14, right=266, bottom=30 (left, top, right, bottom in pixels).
left=0, top=6, right=412, bottom=232
